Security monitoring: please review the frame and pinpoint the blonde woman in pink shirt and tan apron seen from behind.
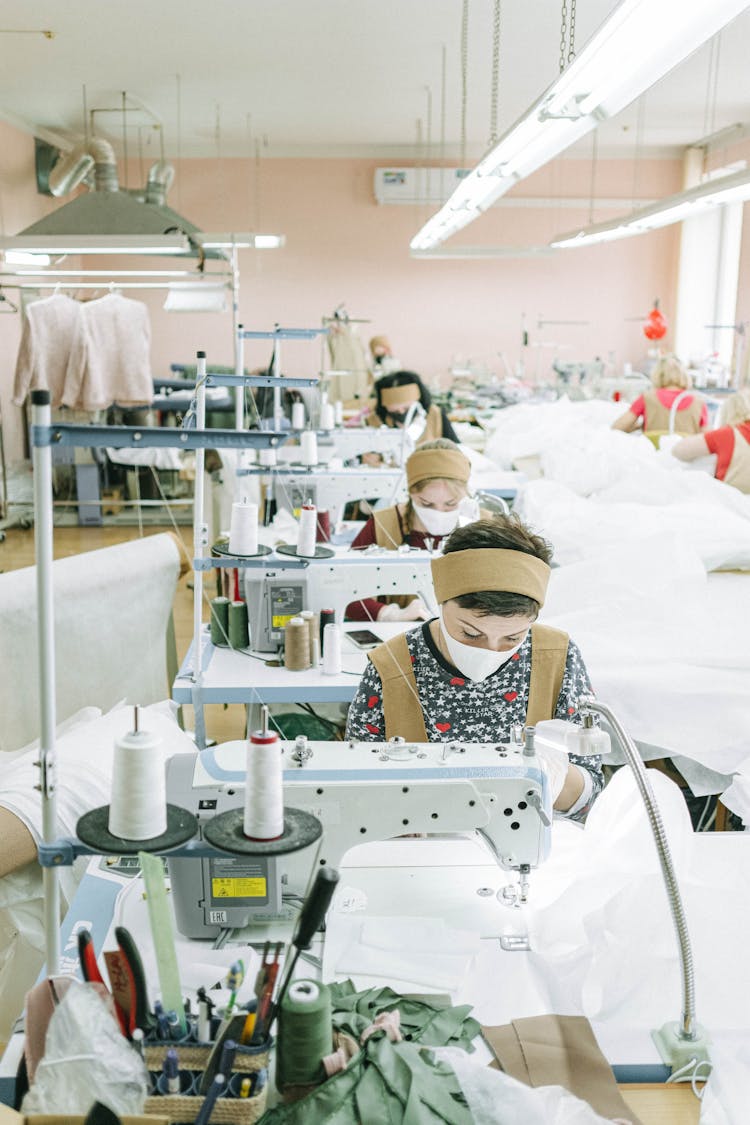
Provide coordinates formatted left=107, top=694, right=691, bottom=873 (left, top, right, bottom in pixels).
left=612, top=356, right=708, bottom=444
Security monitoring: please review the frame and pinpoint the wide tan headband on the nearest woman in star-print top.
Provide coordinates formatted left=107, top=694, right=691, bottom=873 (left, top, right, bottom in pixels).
left=432, top=547, right=550, bottom=605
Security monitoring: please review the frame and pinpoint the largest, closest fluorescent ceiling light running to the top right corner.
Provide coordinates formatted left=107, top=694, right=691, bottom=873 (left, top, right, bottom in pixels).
left=410, top=0, right=748, bottom=250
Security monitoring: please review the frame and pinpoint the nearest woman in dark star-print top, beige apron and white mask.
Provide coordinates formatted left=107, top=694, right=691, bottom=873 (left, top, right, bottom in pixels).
left=346, top=514, right=604, bottom=820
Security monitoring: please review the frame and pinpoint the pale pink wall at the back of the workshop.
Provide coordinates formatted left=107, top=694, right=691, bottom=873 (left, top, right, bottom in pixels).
left=0, top=115, right=750, bottom=460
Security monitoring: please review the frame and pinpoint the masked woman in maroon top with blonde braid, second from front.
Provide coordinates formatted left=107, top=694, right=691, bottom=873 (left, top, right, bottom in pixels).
left=346, top=438, right=480, bottom=621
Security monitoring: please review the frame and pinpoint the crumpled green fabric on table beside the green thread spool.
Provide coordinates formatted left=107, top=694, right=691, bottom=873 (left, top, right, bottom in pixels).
left=261, top=981, right=479, bottom=1125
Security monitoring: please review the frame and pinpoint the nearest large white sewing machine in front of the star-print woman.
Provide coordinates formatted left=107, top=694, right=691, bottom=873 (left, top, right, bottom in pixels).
left=166, top=732, right=552, bottom=938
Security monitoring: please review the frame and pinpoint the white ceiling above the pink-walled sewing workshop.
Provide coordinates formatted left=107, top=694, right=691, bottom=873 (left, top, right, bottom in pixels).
left=0, top=0, right=750, bottom=161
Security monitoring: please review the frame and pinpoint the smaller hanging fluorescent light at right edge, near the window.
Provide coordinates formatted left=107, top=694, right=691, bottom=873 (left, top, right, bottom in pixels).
left=550, top=171, right=750, bottom=249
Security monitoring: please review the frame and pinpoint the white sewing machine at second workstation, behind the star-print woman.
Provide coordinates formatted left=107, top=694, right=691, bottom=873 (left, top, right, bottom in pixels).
left=243, top=548, right=436, bottom=653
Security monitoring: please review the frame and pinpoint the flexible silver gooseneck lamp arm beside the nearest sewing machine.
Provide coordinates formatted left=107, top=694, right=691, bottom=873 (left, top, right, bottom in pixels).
left=578, top=695, right=697, bottom=1042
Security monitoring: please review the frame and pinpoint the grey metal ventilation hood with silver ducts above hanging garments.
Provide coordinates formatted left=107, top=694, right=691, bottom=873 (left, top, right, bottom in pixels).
left=9, top=137, right=220, bottom=259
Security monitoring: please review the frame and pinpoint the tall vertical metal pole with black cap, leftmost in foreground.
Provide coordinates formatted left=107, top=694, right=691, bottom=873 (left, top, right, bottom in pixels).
left=31, top=390, right=60, bottom=977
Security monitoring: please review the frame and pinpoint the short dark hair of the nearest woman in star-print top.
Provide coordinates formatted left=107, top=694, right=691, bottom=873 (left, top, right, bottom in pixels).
left=443, top=512, right=552, bottom=619
